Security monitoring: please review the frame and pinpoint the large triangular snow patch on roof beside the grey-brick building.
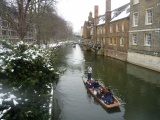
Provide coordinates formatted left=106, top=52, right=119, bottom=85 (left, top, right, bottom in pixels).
left=110, top=5, right=130, bottom=22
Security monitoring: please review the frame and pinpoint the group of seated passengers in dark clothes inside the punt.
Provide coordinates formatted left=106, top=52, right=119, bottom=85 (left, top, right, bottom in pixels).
left=86, top=79, right=114, bottom=105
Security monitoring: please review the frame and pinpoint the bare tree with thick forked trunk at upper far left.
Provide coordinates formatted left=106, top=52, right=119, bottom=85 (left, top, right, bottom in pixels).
left=0, top=0, right=31, bottom=40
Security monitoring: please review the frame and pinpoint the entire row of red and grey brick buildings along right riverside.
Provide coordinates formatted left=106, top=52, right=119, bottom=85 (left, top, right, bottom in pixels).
left=82, top=0, right=160, bottom=72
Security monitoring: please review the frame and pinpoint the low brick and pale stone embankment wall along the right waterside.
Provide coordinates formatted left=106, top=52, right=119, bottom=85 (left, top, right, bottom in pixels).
left=81, top=44, right=160, bottom=72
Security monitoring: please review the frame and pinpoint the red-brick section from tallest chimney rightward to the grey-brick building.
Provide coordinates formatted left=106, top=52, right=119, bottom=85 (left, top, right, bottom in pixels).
left=104, top=0, right=130, bottom=61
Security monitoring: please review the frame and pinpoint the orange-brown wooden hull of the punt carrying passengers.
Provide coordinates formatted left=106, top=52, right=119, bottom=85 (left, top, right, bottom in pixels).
left=82, top=77, right=121, bottom=108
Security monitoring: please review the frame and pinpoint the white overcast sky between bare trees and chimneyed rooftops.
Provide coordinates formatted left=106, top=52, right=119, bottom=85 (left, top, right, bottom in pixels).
left=57, top=0, right=130, bottom=32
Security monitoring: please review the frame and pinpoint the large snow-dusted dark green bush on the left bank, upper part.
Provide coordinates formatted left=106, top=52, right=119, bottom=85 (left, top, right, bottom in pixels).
left=0, top=40, right=56, bottom=84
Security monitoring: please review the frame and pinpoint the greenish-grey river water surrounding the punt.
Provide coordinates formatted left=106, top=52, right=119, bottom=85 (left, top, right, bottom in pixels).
left=53, top=45, right=160, bottom=120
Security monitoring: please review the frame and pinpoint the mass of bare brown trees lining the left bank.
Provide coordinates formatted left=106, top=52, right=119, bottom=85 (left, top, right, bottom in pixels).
left=0, top=0, right=72, bottom=43
